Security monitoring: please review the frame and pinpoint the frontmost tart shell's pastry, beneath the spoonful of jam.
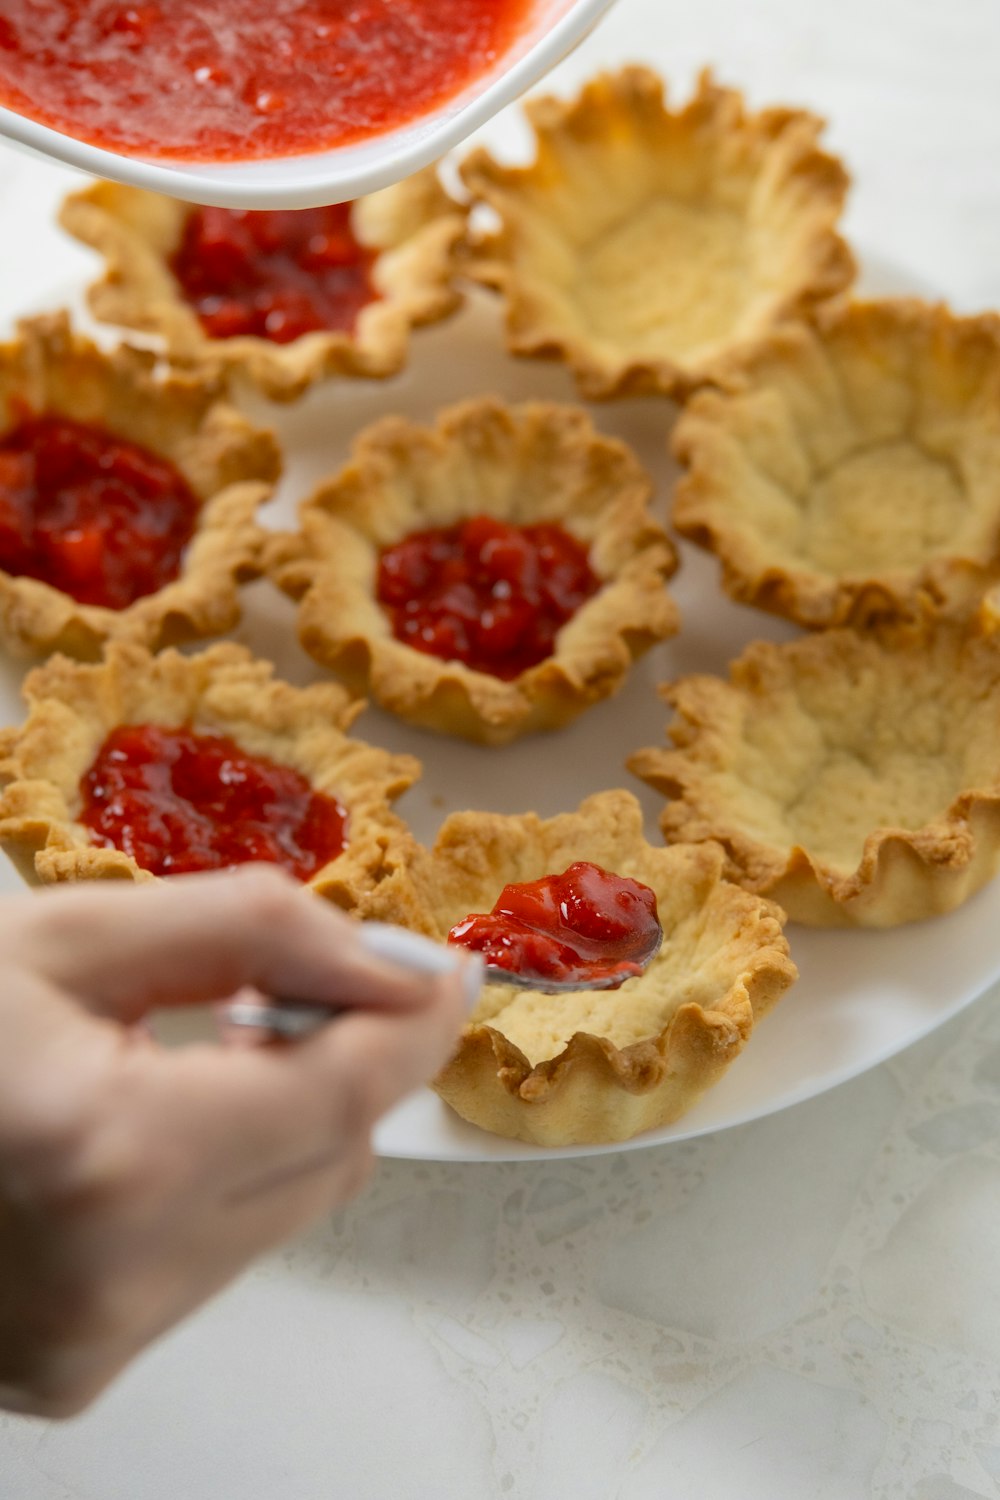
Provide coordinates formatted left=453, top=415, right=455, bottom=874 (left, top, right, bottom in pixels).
left=371, top=791, right=796, bottom=1146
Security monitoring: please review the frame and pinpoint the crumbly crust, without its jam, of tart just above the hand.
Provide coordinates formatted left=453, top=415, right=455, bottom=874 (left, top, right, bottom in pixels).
left=0, top=644, right=420, bottom=915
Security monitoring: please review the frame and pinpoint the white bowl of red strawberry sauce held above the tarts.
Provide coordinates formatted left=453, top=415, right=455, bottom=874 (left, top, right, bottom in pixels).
left=0, top=0, right=615, bottom=209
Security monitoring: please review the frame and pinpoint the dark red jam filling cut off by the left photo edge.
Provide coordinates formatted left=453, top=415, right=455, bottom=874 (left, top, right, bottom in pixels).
left=0, top=416, right=199, bottom=609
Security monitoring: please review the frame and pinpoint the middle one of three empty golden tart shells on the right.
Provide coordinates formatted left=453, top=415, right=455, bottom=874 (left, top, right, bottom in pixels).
left=673, top=302, right=1000, bottom=629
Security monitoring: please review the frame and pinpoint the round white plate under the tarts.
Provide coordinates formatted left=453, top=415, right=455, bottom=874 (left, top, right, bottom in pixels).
left=0, top=249, right=1000, bottom=1161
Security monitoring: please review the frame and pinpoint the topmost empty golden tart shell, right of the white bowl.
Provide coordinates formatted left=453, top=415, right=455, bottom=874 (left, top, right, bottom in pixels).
left=462, top=68, right=855, bottom=399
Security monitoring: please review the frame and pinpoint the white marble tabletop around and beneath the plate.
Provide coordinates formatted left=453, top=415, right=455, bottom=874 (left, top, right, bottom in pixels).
left=0, top=0, right=1000, bottom=1500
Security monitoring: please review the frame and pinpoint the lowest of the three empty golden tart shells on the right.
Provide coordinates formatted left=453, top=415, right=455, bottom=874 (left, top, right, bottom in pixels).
left=628, top=623, right=1000, bottom=927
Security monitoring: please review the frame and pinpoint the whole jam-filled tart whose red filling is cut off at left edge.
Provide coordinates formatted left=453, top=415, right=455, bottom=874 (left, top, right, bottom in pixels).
left=0, top=315, right=280, bottom=659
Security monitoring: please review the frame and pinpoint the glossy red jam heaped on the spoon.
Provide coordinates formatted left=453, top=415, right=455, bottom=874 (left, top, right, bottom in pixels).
left=448, top=860, right=663, bottom=990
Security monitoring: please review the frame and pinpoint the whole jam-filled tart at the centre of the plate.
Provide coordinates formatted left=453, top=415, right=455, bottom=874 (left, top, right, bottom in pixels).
left=268, top=398, right=678, bottom=744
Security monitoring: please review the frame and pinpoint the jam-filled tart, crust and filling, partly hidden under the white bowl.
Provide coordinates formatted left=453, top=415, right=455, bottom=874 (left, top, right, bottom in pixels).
left=60, top=168, right=465, bottom=401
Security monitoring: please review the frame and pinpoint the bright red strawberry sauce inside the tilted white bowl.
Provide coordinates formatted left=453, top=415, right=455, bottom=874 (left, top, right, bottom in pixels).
left=0, top=0, right=534, bottom=162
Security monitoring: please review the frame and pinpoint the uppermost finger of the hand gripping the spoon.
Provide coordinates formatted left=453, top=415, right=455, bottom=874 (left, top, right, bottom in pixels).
left=12, top=866, right=475, bottom=1022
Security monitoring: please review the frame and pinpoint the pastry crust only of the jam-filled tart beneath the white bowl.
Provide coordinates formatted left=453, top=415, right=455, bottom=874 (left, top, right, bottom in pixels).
left=60, top=167, right=465, bottom=401
